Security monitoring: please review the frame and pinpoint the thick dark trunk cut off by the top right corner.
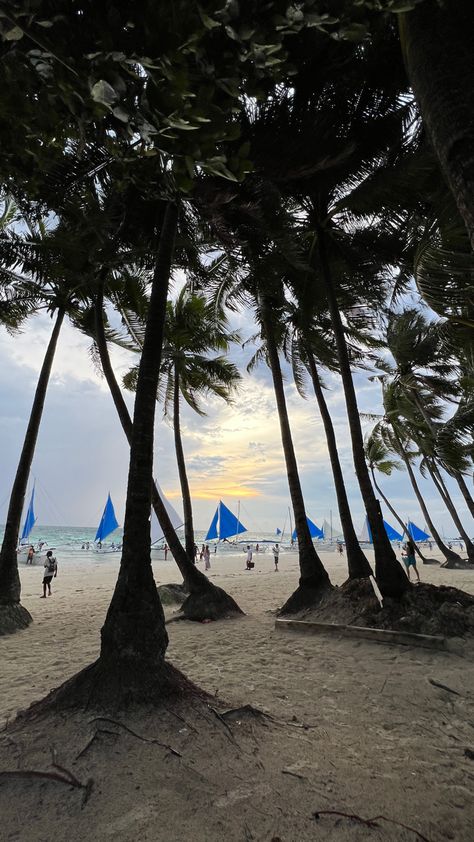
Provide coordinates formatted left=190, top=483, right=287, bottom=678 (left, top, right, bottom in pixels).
left=398, top=0, right=474, bottom=249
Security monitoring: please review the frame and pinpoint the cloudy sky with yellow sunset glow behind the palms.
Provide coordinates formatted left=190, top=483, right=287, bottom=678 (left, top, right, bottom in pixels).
left=0, top=296, right=473, bottom=538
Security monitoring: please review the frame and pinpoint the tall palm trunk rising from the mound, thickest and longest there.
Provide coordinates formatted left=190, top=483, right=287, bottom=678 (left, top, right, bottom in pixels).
left=316, top=223, right=409, bottom=598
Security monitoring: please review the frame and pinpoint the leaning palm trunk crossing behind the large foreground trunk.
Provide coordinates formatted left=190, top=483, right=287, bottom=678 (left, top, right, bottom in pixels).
left=95, top=268, right=242, bottom=620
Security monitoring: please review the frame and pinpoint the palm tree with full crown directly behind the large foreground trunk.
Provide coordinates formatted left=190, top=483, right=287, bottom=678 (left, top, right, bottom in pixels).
left=123, top=286, right=240, bottom=559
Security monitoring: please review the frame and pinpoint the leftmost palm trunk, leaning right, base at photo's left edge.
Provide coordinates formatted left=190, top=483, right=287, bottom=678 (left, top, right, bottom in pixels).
left=0, top=310, right=64, bottom=635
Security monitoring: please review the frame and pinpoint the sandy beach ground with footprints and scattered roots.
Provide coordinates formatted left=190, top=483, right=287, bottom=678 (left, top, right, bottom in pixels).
left=0, top=552, right=474, bottom=842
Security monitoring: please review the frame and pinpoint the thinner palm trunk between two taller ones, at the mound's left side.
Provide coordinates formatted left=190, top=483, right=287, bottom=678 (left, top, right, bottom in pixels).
left=306, top=349, right=372, bottom=579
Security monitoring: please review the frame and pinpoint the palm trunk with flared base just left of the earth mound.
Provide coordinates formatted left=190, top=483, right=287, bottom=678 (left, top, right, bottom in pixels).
left=262, top=303, right=332, bottom=614
